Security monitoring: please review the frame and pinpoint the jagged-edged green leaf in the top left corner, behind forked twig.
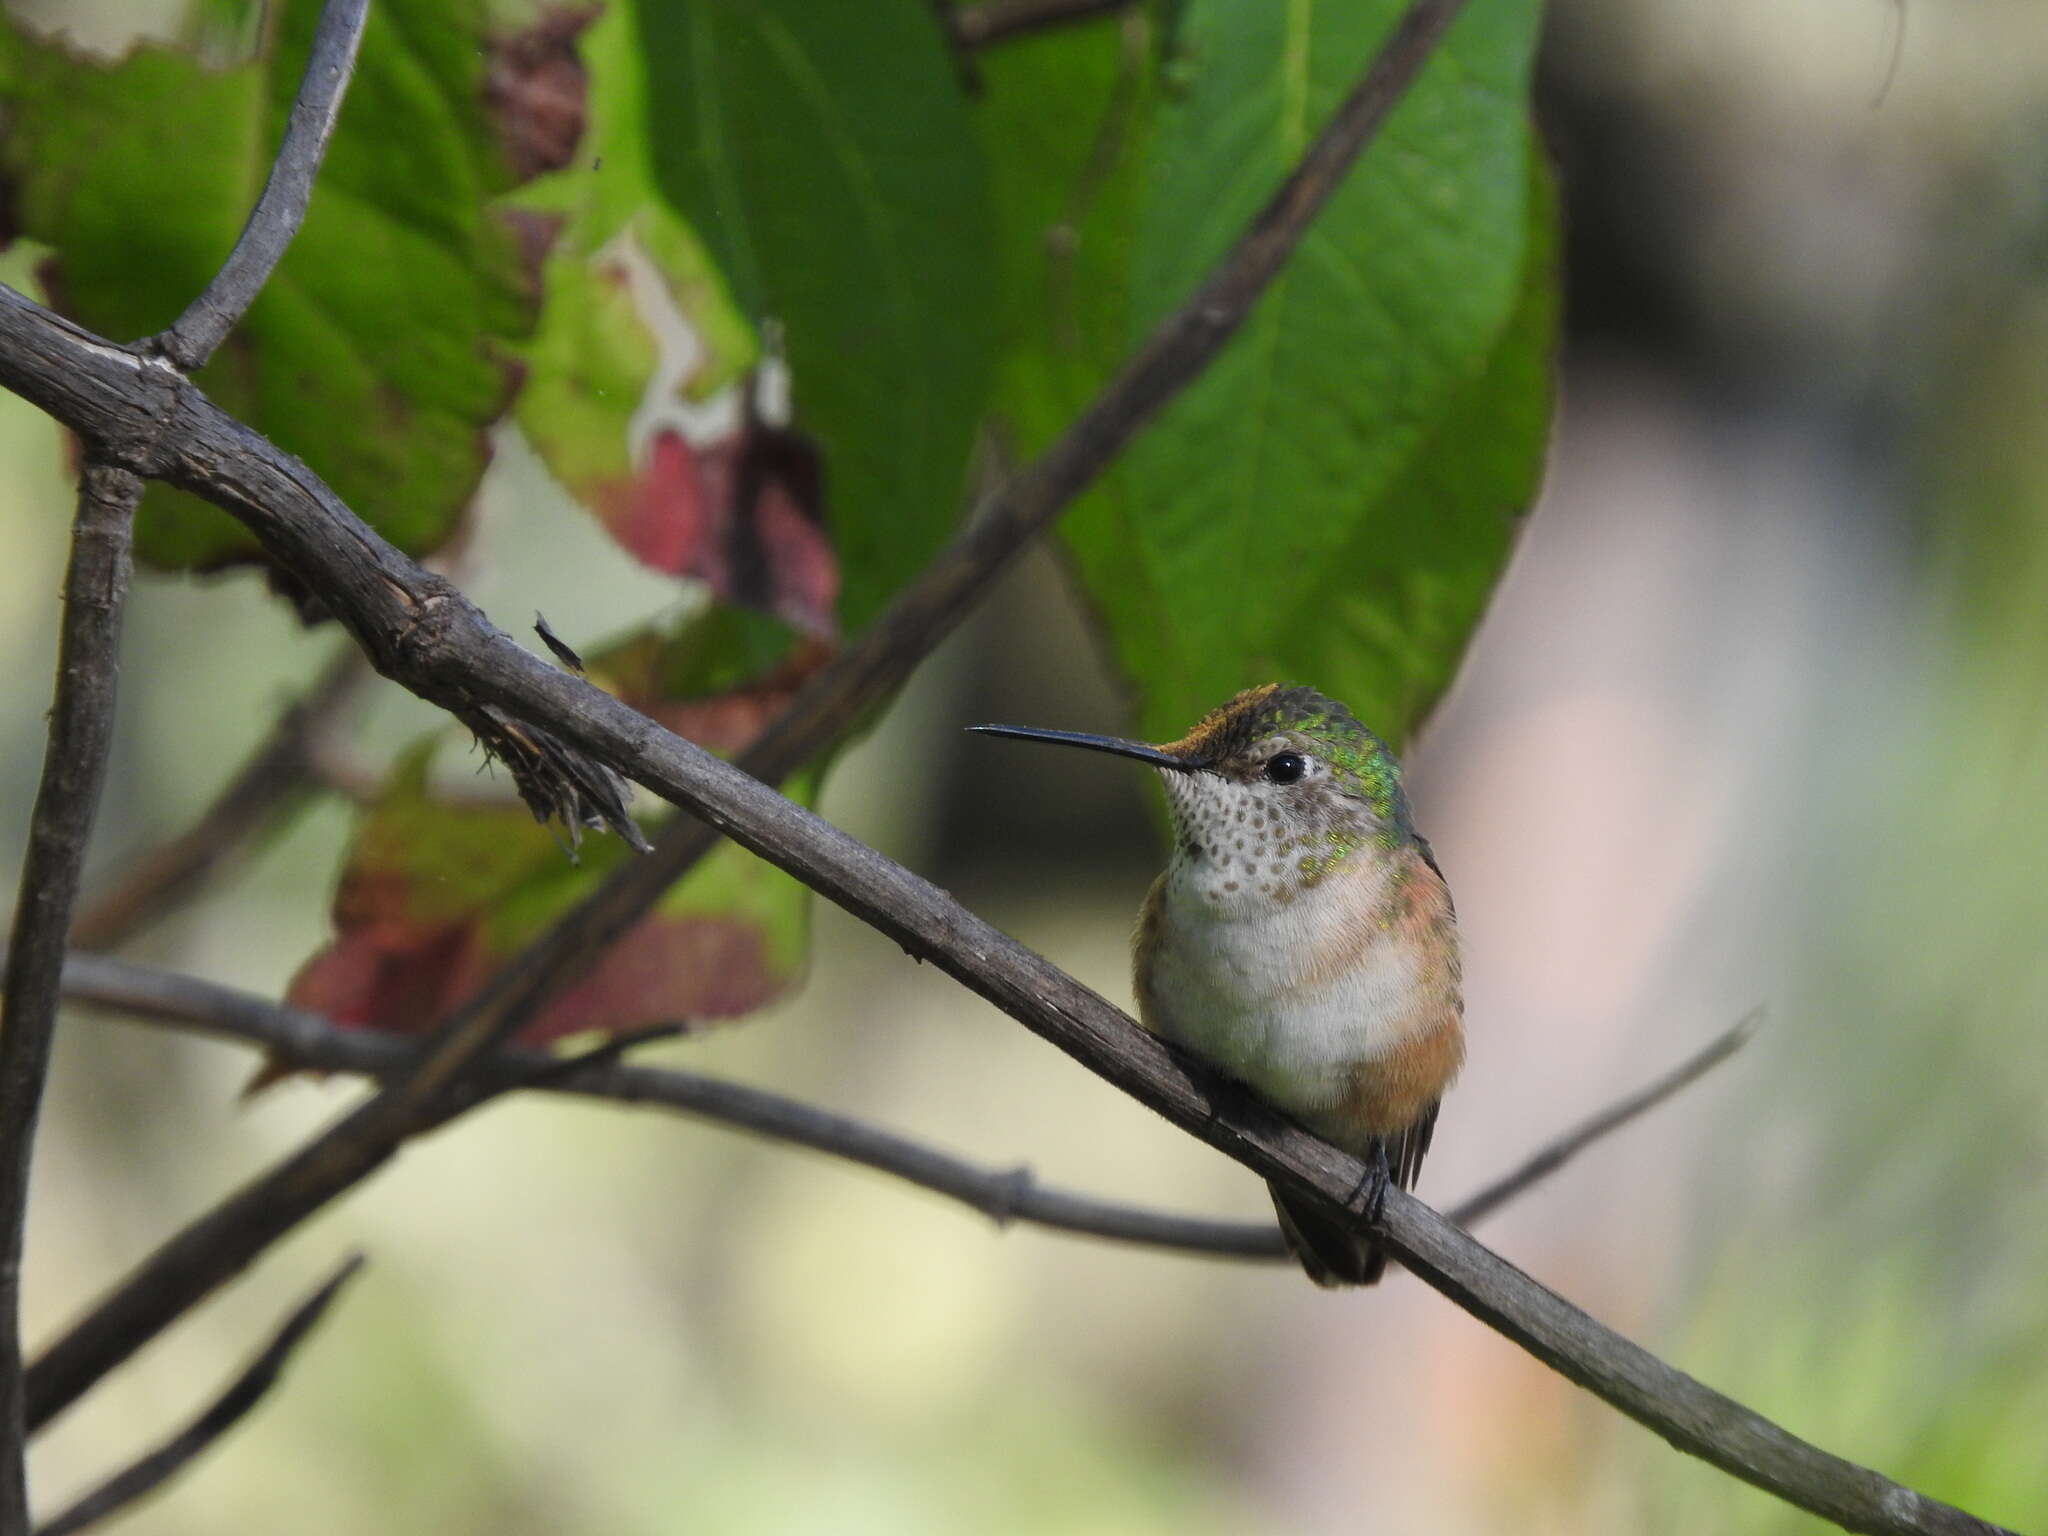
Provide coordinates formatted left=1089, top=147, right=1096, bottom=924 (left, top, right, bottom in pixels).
left=0, top=0, right=535, bottom=567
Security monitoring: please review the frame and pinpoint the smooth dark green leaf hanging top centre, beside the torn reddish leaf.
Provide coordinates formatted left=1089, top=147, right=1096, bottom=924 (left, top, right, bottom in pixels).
left=639, top=0, right=993, bottom=629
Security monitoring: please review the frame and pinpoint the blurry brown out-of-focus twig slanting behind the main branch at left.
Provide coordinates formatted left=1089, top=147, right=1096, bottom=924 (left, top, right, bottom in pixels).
left=72, top=645, right=371, bottom=950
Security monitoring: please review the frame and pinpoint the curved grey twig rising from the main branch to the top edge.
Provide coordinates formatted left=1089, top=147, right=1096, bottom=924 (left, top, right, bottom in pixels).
left=154, top=0, right=371, bottom=373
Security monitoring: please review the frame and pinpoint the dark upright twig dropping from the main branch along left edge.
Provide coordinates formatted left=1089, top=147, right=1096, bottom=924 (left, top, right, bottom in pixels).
left=0, top=459, right=143, bottom=1532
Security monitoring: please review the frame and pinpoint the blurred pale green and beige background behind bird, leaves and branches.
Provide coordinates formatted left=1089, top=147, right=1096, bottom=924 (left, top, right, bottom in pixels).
left=0, top=0, right=2048, bottom=1536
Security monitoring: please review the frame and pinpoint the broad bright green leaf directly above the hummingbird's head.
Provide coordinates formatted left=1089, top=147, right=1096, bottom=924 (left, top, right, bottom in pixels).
left=981, top=0, right=1554, bottom=737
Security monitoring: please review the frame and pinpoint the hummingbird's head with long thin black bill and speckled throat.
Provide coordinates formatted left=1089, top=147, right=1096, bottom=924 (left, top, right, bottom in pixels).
left=971, top=684, right=1415, bottom=899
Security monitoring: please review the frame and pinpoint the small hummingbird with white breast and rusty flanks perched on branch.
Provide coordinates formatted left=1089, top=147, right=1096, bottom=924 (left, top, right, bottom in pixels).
left=971, top=684, right=1464, bottom=1286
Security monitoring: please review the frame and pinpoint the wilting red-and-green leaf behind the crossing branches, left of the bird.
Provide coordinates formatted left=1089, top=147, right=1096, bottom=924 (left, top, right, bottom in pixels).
left=291, top=610, right=823, bottom=1044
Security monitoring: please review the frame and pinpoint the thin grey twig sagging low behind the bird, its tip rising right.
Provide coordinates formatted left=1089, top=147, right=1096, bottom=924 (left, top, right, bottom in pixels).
left=63, top=952, right=1757, bottom=1262
